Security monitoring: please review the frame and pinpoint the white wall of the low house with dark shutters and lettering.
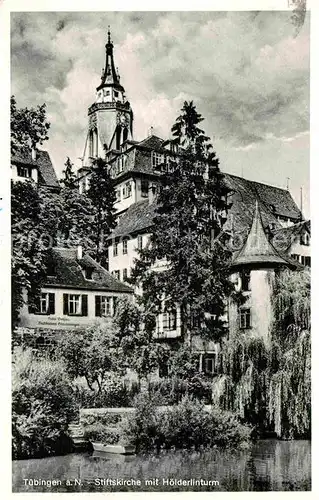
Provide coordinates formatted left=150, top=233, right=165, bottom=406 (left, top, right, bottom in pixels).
left=19, top=287, right=133, bottom=330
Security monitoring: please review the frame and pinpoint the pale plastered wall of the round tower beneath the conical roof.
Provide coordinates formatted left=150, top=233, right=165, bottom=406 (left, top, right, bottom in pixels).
left=228, top=269, right=275, bottom=342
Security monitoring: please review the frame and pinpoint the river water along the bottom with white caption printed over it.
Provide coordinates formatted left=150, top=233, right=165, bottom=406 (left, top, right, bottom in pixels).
left=13, top=440, right=311, bottom=492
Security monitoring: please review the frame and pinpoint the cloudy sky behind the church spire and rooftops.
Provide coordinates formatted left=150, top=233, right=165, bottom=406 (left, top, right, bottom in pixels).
left=11, top=11, right=310, bottom=217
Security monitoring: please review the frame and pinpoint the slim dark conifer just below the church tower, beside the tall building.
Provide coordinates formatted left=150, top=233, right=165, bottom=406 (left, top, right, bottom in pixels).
left=87, top=158, right=116, bottom=263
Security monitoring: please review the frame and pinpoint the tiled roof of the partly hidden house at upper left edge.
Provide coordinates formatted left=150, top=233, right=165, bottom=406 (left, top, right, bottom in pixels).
left=11, top=149, right=59, bottom=188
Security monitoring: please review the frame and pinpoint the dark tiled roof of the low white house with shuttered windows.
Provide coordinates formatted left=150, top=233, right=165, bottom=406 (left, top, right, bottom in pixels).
left=45, top=248, right=133, bottom=293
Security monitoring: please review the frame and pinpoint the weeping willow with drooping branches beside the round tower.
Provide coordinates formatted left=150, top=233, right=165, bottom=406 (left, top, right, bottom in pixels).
left=213, top=270, right=311, bottom=438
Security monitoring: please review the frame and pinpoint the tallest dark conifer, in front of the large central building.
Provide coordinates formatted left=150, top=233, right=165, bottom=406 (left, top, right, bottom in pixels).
left=132, top=102, right=234, bottom=343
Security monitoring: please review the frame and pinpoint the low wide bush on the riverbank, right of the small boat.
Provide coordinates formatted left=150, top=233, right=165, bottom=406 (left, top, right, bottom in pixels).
left=122, top=395, right=251, bottom=451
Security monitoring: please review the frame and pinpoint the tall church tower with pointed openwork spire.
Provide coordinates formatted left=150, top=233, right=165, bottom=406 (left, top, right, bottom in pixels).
left=82, top=29, right=133, bottom=168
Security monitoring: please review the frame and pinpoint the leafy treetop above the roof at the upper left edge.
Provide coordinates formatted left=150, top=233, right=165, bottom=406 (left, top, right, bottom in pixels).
left=10, top=96, right=50, bottom=155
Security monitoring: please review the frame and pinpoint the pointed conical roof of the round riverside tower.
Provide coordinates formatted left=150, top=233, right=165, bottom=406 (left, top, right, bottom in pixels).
left=233, top=200, right=291, bottom=266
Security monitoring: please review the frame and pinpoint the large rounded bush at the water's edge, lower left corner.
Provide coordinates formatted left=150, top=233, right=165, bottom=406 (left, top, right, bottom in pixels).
left=12, top=347, right=77, bottom=458
